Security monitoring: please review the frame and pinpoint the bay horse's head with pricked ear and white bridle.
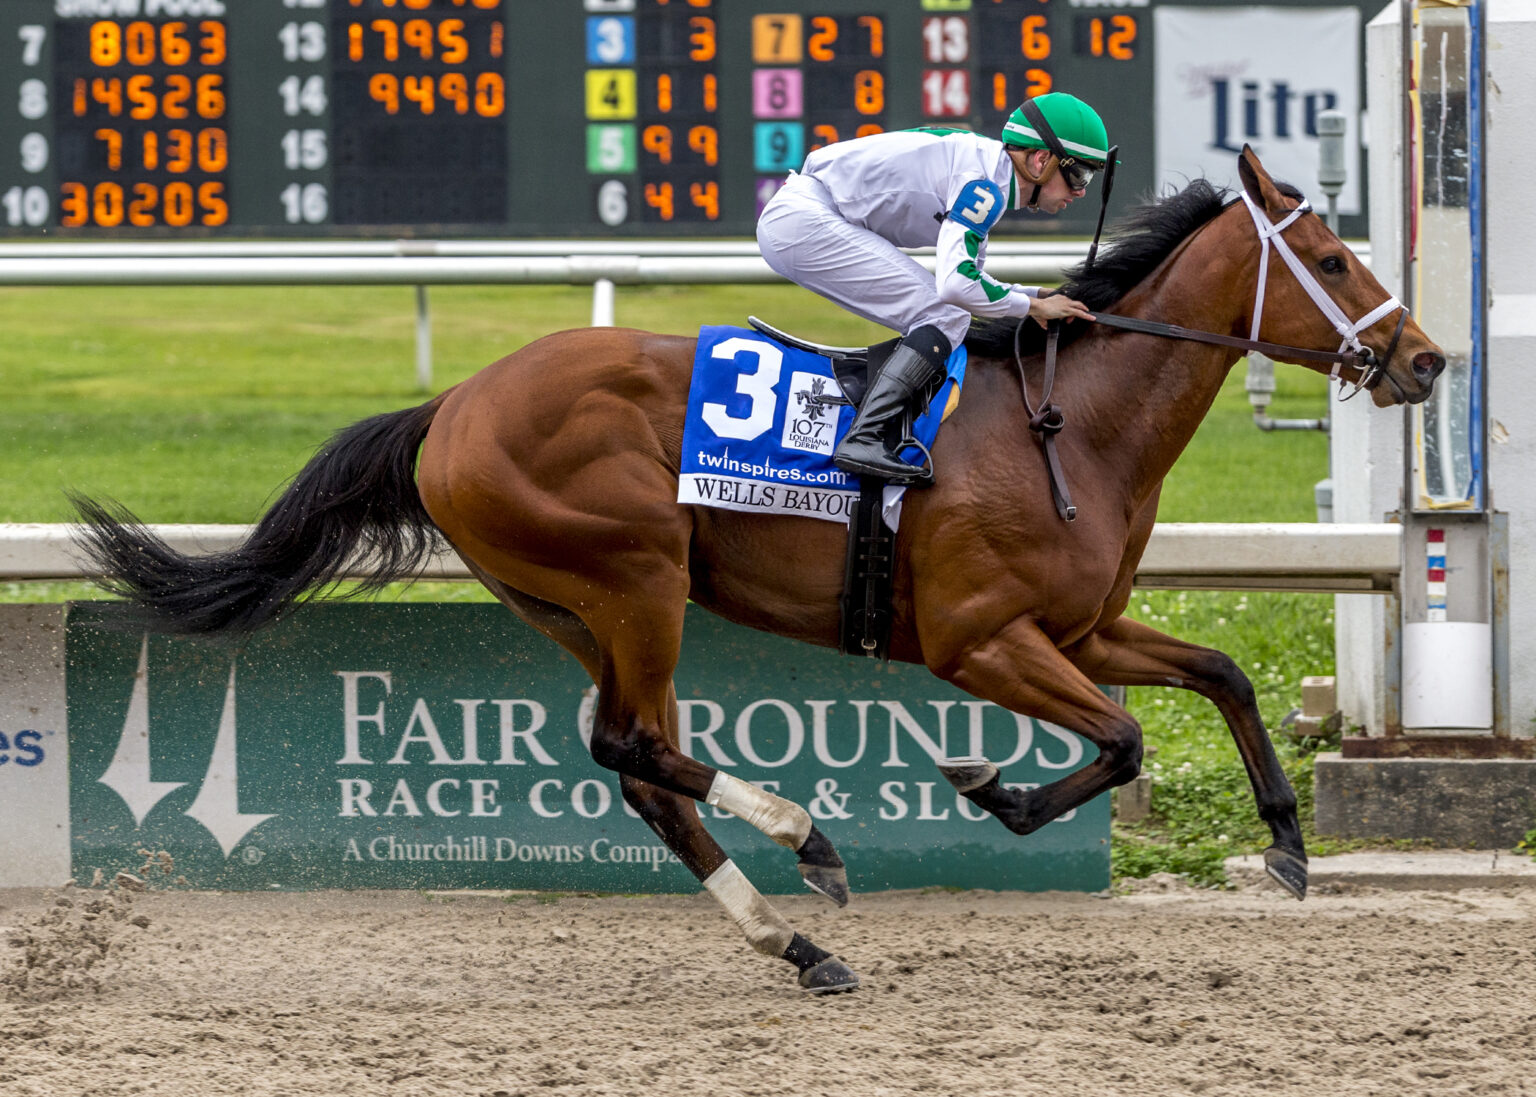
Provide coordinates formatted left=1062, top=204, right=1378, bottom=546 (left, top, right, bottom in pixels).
left=1238, top=146, right=1445, bottom=407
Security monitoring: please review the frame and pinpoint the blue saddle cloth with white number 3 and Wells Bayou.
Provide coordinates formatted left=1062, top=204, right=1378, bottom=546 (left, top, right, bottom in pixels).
left=677, top=326, right=965, bottom=524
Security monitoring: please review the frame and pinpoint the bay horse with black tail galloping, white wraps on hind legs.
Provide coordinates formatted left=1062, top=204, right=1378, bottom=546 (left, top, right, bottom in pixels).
left=75, top=149, right=1445, bottom=991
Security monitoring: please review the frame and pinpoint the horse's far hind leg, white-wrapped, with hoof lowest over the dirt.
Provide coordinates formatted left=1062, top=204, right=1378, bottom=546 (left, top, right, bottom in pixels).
left=470, top=564, right=859, bottom=994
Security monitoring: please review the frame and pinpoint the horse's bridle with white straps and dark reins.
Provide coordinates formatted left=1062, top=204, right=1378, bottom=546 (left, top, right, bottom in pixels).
left=1014, top=192, right=1409, bottom=522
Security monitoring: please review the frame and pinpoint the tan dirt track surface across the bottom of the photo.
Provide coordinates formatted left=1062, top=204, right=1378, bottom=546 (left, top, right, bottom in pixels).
left=0, top=887, right=1536, bottom=1097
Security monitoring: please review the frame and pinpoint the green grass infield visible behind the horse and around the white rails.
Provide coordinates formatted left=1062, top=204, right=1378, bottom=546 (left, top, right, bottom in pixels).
left=0, top=286, right=1333, bottom=883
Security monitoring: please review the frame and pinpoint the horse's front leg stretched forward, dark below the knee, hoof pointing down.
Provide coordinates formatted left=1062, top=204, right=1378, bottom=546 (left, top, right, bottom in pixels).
left=1072, top=618, right=1307, bottom=899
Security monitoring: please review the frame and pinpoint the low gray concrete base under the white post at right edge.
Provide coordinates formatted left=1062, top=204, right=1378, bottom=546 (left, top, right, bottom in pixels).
left=1315, top=753, right=1536, bottom=850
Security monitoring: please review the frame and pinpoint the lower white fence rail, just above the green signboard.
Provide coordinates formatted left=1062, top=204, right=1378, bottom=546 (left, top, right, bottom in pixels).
left=0, top=522, right=1402, bottom=593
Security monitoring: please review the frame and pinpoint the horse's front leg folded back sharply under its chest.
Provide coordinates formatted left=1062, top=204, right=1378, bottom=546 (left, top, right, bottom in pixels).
left=931, top=618, right=1141, bottom=834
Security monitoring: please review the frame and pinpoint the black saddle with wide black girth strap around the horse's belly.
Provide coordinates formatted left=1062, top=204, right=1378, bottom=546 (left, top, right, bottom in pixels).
left=746, top=317, right=911, bottom=659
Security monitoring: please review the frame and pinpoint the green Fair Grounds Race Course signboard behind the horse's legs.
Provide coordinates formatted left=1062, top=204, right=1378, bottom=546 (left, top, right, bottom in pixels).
left=66, top=604, right=1109, bottom=893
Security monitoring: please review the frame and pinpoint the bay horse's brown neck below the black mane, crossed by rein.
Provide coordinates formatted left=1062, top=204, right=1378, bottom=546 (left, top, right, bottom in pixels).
left=1060, top=217, right=1253, bottom=496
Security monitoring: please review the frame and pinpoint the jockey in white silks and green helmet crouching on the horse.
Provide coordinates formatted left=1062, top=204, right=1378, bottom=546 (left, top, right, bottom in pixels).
left=757, top=92, right=1109, bottom=484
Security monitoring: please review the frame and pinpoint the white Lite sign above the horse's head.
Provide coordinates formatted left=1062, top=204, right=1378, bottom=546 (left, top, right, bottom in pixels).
left=1154, top=6, right=1362, bottom=214
